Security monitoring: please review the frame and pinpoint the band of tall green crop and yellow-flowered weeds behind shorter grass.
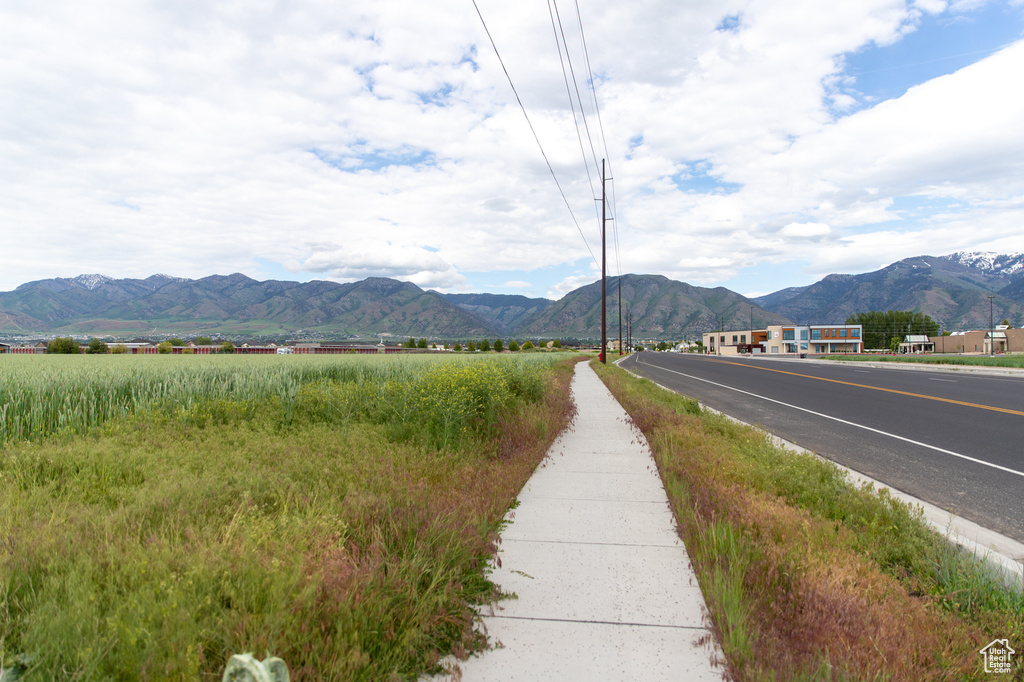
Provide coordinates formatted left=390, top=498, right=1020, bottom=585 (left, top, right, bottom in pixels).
left=0, top=354, right=553, bottom=443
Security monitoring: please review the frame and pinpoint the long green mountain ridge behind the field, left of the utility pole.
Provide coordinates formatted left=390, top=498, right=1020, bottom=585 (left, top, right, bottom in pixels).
left=0, top=273, right=497, bottom=337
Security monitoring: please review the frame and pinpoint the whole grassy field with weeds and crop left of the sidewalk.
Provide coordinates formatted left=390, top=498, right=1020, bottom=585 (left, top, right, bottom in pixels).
left=0, top=354, right=572, bottom=680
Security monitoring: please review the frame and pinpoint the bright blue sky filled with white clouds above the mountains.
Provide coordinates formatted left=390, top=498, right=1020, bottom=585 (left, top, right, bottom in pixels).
left=0, top=0, right=1024, bottom=299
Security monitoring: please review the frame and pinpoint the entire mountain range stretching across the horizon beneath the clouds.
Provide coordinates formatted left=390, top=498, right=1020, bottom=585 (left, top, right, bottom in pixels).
left=0, top=252, right=1024, bottom=340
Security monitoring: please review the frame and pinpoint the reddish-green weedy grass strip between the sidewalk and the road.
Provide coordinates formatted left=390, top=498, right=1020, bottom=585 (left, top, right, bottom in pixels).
left=594, top=363, right=1024, bottom=680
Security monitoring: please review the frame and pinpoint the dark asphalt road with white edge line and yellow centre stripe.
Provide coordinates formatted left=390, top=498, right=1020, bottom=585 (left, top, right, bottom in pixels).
left=623, top=352, right=1024, bottom=542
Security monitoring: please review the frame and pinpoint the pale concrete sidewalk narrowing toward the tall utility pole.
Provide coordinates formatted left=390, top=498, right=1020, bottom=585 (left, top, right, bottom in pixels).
left=452, top=363, right=724, bottom=682
